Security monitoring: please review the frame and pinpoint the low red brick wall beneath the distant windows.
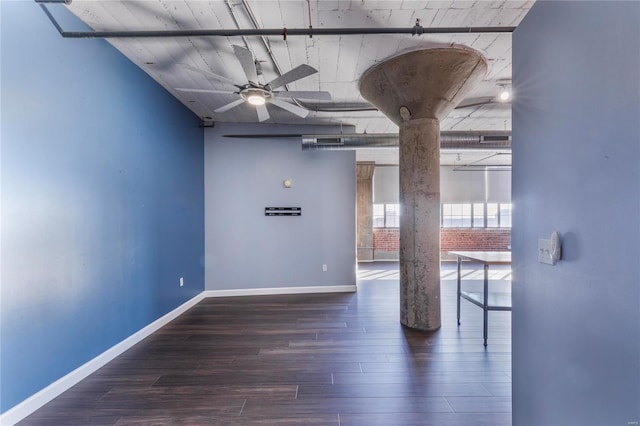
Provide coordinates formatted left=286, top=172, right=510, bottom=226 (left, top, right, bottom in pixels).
left=373, top=228, right=511, bottom=260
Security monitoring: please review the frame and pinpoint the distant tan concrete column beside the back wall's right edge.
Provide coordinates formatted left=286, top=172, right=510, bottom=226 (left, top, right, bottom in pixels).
left=356, top=162, right=375, bottom=262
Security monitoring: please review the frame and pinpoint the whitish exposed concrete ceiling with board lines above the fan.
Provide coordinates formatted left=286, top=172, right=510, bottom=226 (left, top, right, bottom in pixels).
left=51, top=0, right=534, bottom=165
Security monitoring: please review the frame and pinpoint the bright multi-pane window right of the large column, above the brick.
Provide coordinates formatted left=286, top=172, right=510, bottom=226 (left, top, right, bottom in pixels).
left=441, top=203, right=511, bottom=228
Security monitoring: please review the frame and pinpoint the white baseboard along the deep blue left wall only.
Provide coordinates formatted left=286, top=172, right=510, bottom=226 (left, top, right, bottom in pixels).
left=0, top=293, right=205, bottom=426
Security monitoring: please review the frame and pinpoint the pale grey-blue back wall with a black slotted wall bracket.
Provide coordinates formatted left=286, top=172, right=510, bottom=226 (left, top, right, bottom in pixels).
left=205, top=124, right=356, bottom=290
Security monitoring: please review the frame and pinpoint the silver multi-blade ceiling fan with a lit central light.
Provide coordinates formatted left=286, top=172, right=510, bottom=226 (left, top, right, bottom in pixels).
left=175, top=46, right=331, bottom=121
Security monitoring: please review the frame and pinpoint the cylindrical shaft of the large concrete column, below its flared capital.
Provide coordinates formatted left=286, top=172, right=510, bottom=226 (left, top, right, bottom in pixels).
left=399, top=118, right=440, bottom=330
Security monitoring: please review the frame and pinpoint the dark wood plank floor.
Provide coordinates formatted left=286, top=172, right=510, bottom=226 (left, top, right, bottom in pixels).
left=19, top=263, right=511, bottom=426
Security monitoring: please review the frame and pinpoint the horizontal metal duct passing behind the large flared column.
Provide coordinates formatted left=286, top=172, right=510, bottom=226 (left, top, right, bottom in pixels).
left=302, top=131, right=511, bottom=151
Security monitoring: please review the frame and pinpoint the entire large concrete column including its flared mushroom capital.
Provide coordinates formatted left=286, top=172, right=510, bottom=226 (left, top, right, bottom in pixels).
left=360, top=47, right=487, bottom=330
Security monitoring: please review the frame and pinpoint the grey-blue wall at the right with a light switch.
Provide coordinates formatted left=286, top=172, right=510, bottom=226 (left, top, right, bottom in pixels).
left=512, top=1, right=640, bottom=426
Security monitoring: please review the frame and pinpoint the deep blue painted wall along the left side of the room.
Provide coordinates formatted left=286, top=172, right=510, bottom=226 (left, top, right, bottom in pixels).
left=0, top=2, right=204, bottom=412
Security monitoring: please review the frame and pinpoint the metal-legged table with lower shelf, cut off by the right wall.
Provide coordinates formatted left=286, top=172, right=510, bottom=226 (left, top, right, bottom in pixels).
left=449, top=251, right=511, bottom=347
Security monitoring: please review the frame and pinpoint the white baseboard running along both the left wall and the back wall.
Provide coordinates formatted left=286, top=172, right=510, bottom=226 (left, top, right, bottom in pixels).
left=0, top=285, right=357, bottom=426
